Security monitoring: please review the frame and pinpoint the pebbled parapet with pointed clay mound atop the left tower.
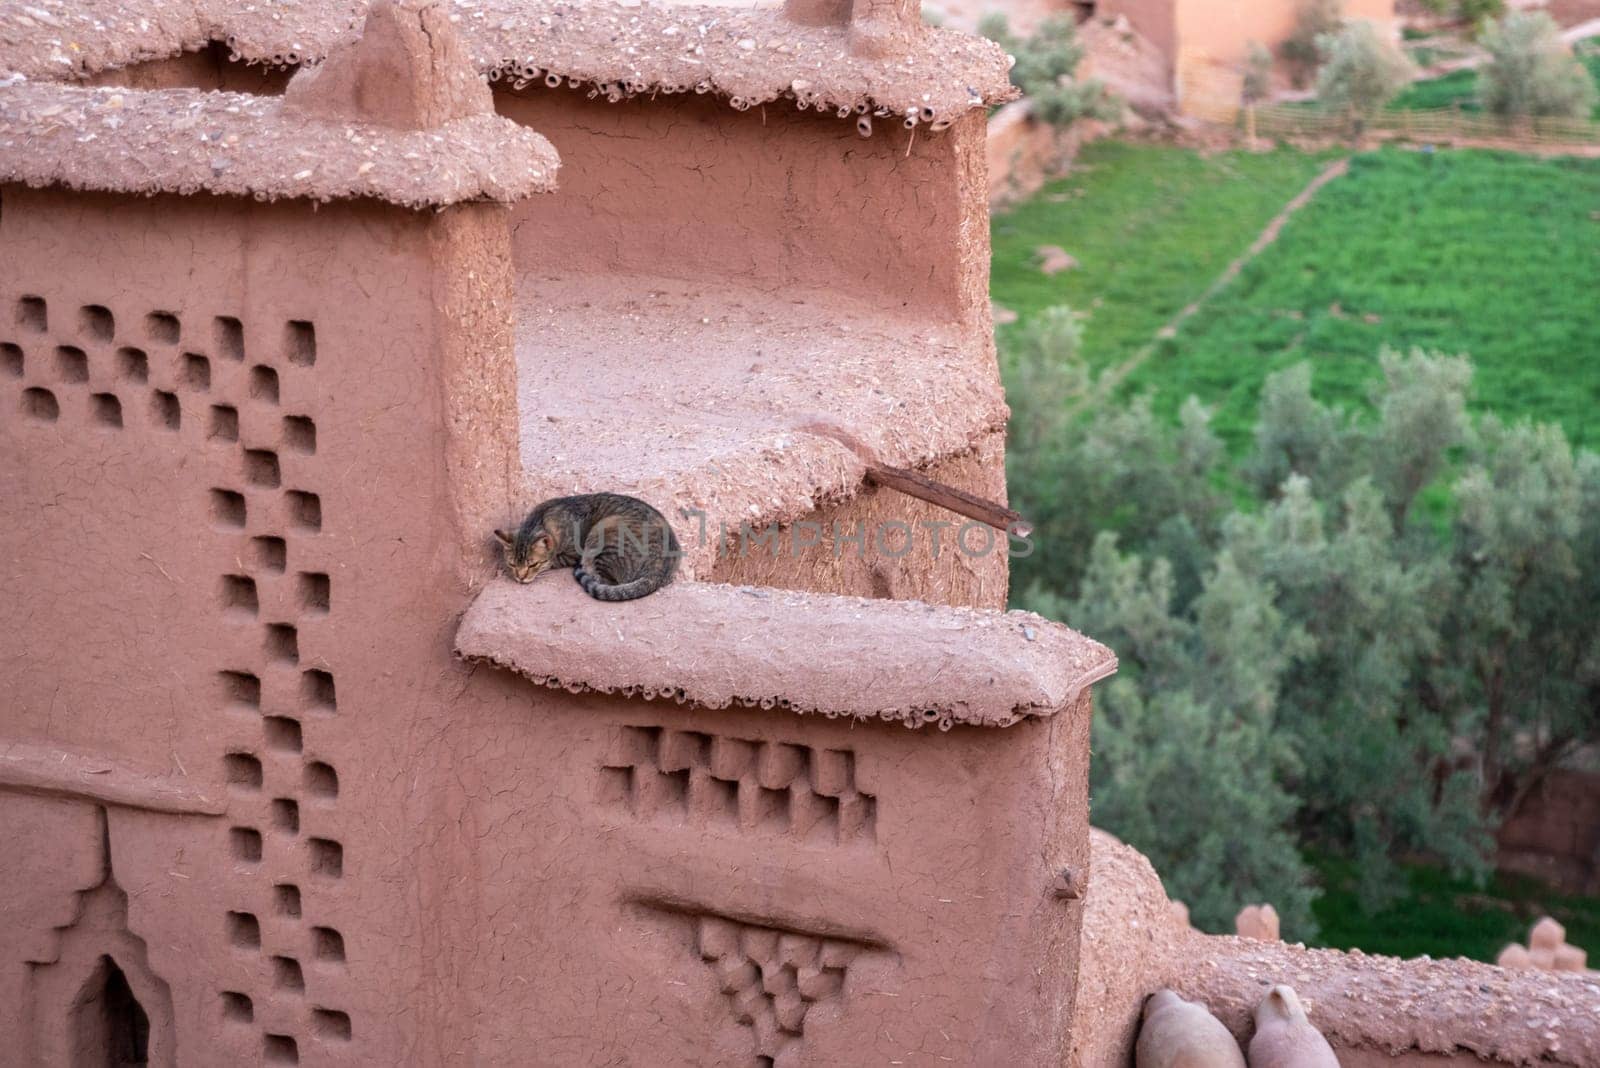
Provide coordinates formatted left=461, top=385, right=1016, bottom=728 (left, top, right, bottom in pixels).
left=0, top=3, right=558, bottom=208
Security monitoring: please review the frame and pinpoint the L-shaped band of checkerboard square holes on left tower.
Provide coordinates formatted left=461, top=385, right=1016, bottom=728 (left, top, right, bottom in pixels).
left=0, top=294, right=354, bottom=1063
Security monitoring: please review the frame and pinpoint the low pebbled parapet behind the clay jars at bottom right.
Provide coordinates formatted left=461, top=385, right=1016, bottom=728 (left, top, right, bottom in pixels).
left=1067, top=831, right=1600, bottom=1068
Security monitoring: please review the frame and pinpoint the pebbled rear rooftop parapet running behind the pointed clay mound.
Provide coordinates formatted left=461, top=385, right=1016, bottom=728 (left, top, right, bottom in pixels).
left=0, top=0, right=1014, bottom=125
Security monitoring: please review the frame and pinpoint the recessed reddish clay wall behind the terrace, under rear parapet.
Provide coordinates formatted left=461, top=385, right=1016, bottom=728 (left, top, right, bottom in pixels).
left=494, top=86, right=989, bottom=326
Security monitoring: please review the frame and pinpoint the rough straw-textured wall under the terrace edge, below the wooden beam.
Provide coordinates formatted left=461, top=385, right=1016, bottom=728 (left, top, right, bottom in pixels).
left=709, top=433, right=1026, bottom=609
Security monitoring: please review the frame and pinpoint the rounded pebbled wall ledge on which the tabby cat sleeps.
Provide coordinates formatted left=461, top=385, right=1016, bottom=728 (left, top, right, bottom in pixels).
left=456, top=571, right=1117, bottom=729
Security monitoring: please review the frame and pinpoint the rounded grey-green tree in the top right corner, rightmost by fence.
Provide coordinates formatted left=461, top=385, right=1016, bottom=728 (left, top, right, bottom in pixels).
left=1478, top=11, right=1597, bottom=118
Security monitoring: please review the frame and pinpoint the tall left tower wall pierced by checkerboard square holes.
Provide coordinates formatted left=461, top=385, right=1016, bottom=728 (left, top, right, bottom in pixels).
left=0, top=187, right=515, bottom=1063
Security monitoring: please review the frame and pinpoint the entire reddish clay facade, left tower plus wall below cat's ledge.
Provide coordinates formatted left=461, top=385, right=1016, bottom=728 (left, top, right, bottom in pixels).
left=0, top=171, right=1088, bottom=1065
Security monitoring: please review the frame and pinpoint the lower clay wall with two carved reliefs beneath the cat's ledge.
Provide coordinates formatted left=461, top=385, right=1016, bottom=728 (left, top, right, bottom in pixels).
left=435, top=675, right=1088, bottom=1065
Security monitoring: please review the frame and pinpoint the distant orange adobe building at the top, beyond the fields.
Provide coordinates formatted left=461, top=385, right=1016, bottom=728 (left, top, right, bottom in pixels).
left=1100, top=0, right=1400, bottom=122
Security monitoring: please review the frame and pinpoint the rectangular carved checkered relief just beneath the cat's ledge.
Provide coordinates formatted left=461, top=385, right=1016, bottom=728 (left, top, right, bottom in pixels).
left=600, top=726, right=877, bottom=844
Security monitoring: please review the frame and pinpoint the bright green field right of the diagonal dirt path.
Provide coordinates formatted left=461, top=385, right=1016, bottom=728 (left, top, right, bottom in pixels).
left=1120, top=149, right=1600, bottom=446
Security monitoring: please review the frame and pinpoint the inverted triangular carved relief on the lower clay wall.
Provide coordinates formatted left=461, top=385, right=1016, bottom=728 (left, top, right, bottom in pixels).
left=694, top=915, right=861, bottom=1066
